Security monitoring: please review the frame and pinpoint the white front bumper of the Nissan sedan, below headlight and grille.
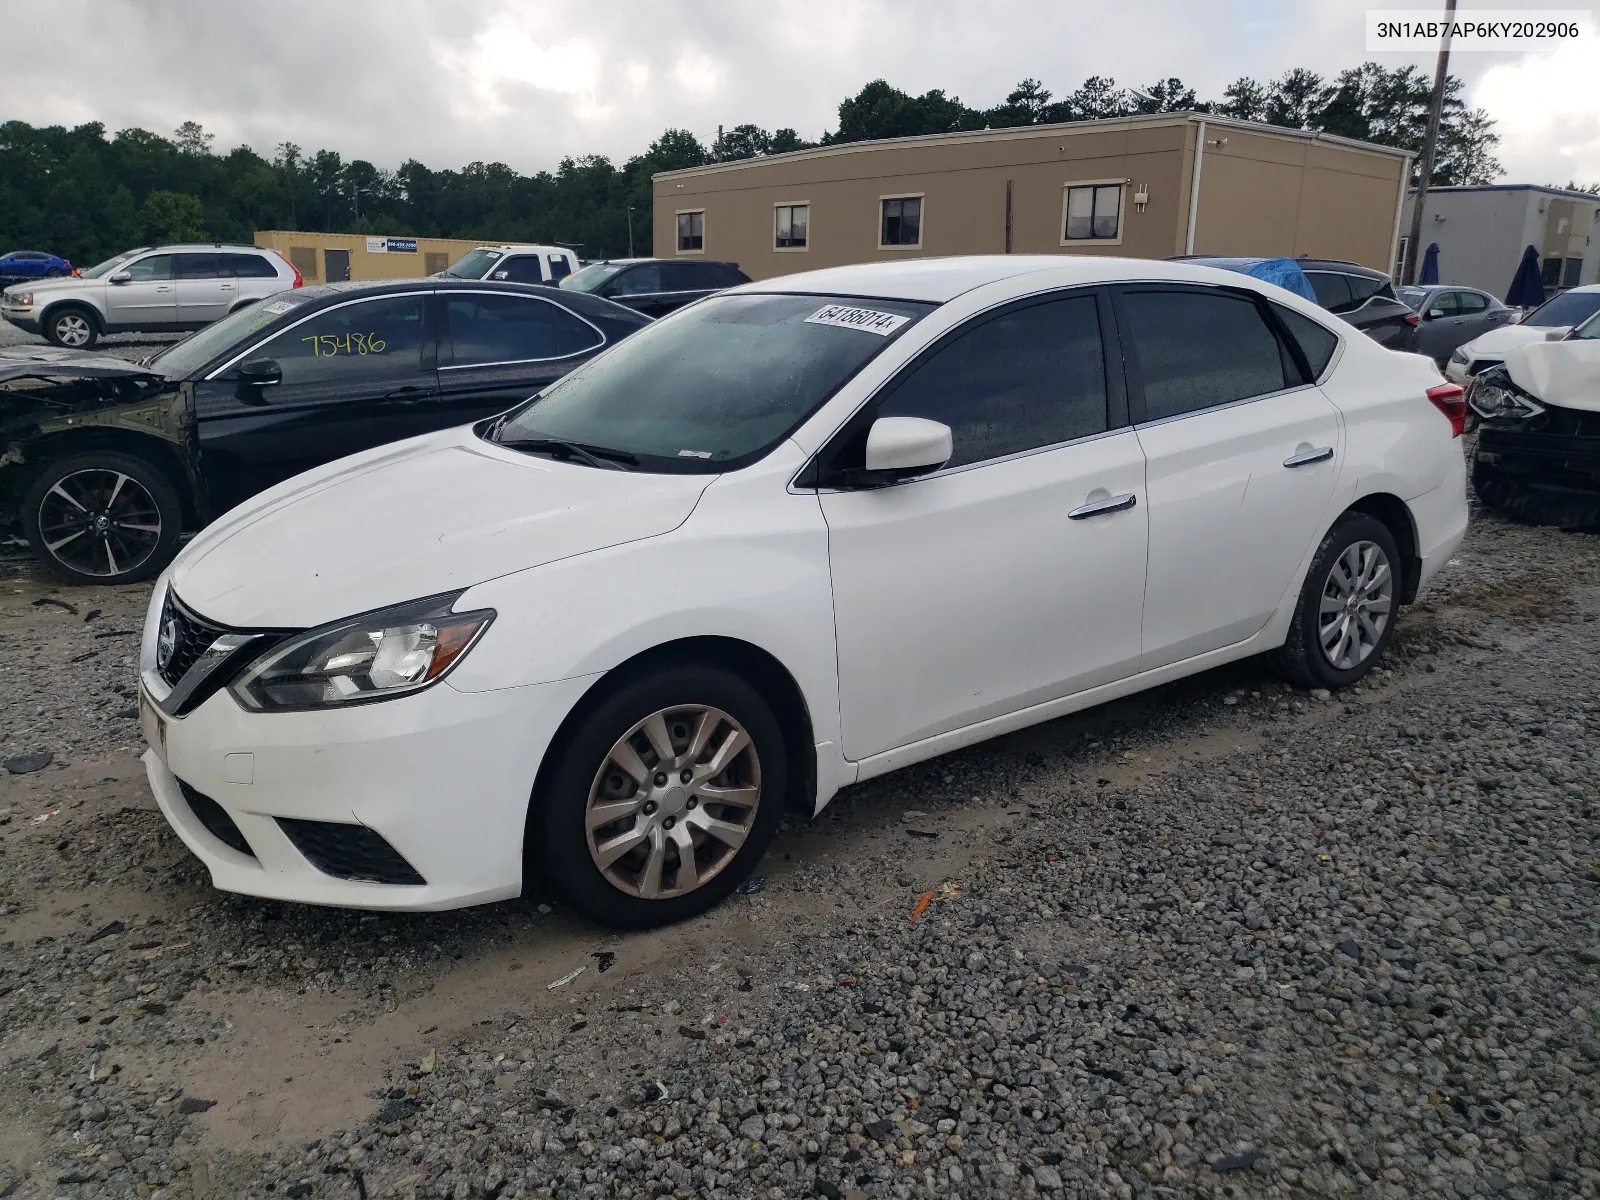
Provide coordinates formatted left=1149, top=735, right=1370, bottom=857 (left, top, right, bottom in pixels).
left=141, top=678, right=592, bottom=910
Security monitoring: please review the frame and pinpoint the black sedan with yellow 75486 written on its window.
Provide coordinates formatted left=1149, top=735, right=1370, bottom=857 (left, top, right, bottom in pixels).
left=0, top=278, right=650, bottom=584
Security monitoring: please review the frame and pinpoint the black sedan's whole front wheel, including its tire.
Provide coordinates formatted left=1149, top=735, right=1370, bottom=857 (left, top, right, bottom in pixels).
left=22, top=450, right=184, bottom=584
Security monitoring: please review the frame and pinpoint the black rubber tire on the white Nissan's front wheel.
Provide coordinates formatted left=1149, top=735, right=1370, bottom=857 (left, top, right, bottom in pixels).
left=525, top=664, right=789, bottom=930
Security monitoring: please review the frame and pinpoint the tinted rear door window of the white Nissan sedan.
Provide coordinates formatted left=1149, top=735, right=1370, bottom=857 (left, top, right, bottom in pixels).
left=1122, top=290, right=1299, bottom=421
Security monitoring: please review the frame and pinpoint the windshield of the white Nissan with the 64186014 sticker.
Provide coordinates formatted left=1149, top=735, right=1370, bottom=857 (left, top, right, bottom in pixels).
left=494, top=293, right=933, bottom=474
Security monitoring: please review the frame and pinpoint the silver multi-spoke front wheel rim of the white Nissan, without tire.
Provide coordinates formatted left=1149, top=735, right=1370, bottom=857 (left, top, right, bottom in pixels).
left=584, top=704, right=762, bottom=899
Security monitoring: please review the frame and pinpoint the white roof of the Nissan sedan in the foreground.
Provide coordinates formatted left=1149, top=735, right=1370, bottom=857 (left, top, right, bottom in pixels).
left=738, top=254, right=1318, bottom=304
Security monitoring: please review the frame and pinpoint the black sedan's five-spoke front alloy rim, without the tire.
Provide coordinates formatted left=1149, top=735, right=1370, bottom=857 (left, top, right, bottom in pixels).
left=38, top=467, right=162, bottom=579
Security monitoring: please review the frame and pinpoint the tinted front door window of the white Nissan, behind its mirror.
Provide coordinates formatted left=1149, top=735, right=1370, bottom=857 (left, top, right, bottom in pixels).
left=877, top=294, right=1107, bottom=467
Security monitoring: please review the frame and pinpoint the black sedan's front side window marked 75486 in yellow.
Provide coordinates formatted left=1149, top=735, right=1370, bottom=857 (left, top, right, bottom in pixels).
left=250, top=293, right=422, bottom=386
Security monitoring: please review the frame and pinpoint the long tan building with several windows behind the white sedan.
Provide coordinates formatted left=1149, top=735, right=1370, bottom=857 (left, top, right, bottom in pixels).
left=653, top=112, right=1411, bottom=278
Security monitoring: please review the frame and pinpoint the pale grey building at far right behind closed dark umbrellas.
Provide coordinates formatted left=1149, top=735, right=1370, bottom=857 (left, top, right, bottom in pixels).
left=1395, top=184, right=1600, bottom=299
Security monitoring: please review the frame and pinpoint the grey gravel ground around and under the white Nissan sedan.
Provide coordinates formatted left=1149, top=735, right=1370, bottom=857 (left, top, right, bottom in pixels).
left=0, top=489, right=1600, bottom=1200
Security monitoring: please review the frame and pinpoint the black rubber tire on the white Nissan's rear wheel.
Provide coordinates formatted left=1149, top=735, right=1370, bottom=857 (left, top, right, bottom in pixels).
left=1267, top=512, right=1403, bottom=691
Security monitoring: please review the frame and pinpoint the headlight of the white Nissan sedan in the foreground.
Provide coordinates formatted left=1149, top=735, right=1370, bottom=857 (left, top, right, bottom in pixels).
left=229, top=592, right=494, bottom=712
